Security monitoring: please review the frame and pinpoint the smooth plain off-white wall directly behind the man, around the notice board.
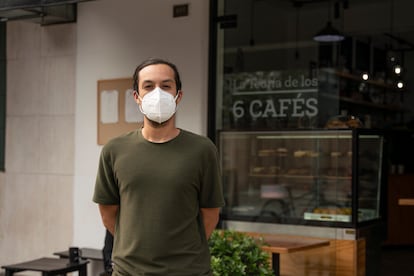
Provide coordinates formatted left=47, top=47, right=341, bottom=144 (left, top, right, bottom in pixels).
left=73, top=0, right=209, bottom=248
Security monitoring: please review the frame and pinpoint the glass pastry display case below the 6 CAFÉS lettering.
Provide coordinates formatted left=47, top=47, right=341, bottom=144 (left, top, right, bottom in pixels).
left=219, top=129, right=384, bottom=228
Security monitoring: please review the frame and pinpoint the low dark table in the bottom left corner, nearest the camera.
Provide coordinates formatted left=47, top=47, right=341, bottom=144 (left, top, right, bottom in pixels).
left=2, top=258, right=88, bottom=276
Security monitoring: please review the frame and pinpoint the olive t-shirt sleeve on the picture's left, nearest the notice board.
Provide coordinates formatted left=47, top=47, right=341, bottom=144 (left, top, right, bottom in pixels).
left=93, top=147, right=120, bottom=205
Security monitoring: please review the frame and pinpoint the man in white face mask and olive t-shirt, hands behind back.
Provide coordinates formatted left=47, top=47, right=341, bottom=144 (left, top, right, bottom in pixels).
left=93, top=59, right=224, bottom=276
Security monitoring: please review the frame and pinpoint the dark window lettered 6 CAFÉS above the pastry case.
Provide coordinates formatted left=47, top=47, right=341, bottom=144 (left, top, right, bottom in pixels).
left=212, top=0, right=408, bottom=134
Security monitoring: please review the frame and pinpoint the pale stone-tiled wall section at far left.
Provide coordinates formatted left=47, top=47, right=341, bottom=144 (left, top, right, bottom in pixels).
left=0, top=21, right=76, bottom=266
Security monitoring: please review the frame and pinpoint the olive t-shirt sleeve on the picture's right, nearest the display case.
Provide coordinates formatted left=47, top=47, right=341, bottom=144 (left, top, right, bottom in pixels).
left=200, top=141, right=224, bottom=208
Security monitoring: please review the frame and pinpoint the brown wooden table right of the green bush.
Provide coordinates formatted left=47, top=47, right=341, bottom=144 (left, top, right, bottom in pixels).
left=247, top=233, right=329, bottom=276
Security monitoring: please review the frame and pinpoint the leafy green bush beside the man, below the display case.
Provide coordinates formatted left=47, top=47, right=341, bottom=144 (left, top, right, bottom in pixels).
left=209, top=230, right=274, bottom=276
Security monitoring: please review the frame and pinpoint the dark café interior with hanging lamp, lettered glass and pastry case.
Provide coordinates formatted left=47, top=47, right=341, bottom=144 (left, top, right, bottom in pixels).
left=209, top=0, right=414, bottom=275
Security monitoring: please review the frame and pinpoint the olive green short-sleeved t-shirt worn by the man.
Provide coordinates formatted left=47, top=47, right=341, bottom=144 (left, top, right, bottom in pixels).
left=93, top=129, right=224, bottom=276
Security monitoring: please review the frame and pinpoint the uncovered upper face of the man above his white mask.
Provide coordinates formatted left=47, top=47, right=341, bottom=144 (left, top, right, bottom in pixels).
left=137, top=64, right=177, bottom=99
